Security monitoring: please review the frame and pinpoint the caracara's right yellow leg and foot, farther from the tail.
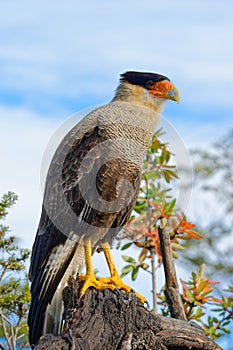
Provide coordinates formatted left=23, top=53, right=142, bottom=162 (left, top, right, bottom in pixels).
left=99, top=242, right=146, bottom=304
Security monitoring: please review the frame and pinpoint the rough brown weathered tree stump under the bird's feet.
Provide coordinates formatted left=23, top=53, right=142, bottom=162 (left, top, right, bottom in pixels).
left=34, top=280, right=221, bottom=350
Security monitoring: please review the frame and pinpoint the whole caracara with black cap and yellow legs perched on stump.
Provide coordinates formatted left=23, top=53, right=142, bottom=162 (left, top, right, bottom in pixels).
left=28, top=71, right=179, bottom=344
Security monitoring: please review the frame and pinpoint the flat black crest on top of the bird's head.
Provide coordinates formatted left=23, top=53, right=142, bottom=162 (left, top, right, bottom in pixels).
left=120, top=71, right=170, bottom=88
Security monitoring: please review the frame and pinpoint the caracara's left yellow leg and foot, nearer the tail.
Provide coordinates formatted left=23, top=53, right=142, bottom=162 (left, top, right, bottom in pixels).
left=79, top=238, right=115, bottom=295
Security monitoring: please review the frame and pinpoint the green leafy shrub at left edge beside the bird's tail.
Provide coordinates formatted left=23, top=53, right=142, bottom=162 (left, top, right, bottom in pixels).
left=0, top=192, right=30, bottom=350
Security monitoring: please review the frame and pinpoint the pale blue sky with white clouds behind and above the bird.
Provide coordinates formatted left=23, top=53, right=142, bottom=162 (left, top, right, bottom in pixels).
left=0, top=0, right=233, bottom=344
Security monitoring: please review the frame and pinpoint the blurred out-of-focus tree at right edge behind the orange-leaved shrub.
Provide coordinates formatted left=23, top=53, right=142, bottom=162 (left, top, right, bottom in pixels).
left=184, top=129, right=233, bottom=284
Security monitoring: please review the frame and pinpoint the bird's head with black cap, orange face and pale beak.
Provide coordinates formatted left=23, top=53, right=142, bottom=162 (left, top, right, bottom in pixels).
left=113, top=71, right=180, bottom=112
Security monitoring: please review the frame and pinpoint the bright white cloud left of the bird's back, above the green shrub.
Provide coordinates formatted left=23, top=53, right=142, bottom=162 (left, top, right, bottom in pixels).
left=0, top=106, right=57, bottom=247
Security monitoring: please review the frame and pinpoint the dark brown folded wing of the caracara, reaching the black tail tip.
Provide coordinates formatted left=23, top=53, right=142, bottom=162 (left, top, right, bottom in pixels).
left=28, top=113, right=140, bottom=343
